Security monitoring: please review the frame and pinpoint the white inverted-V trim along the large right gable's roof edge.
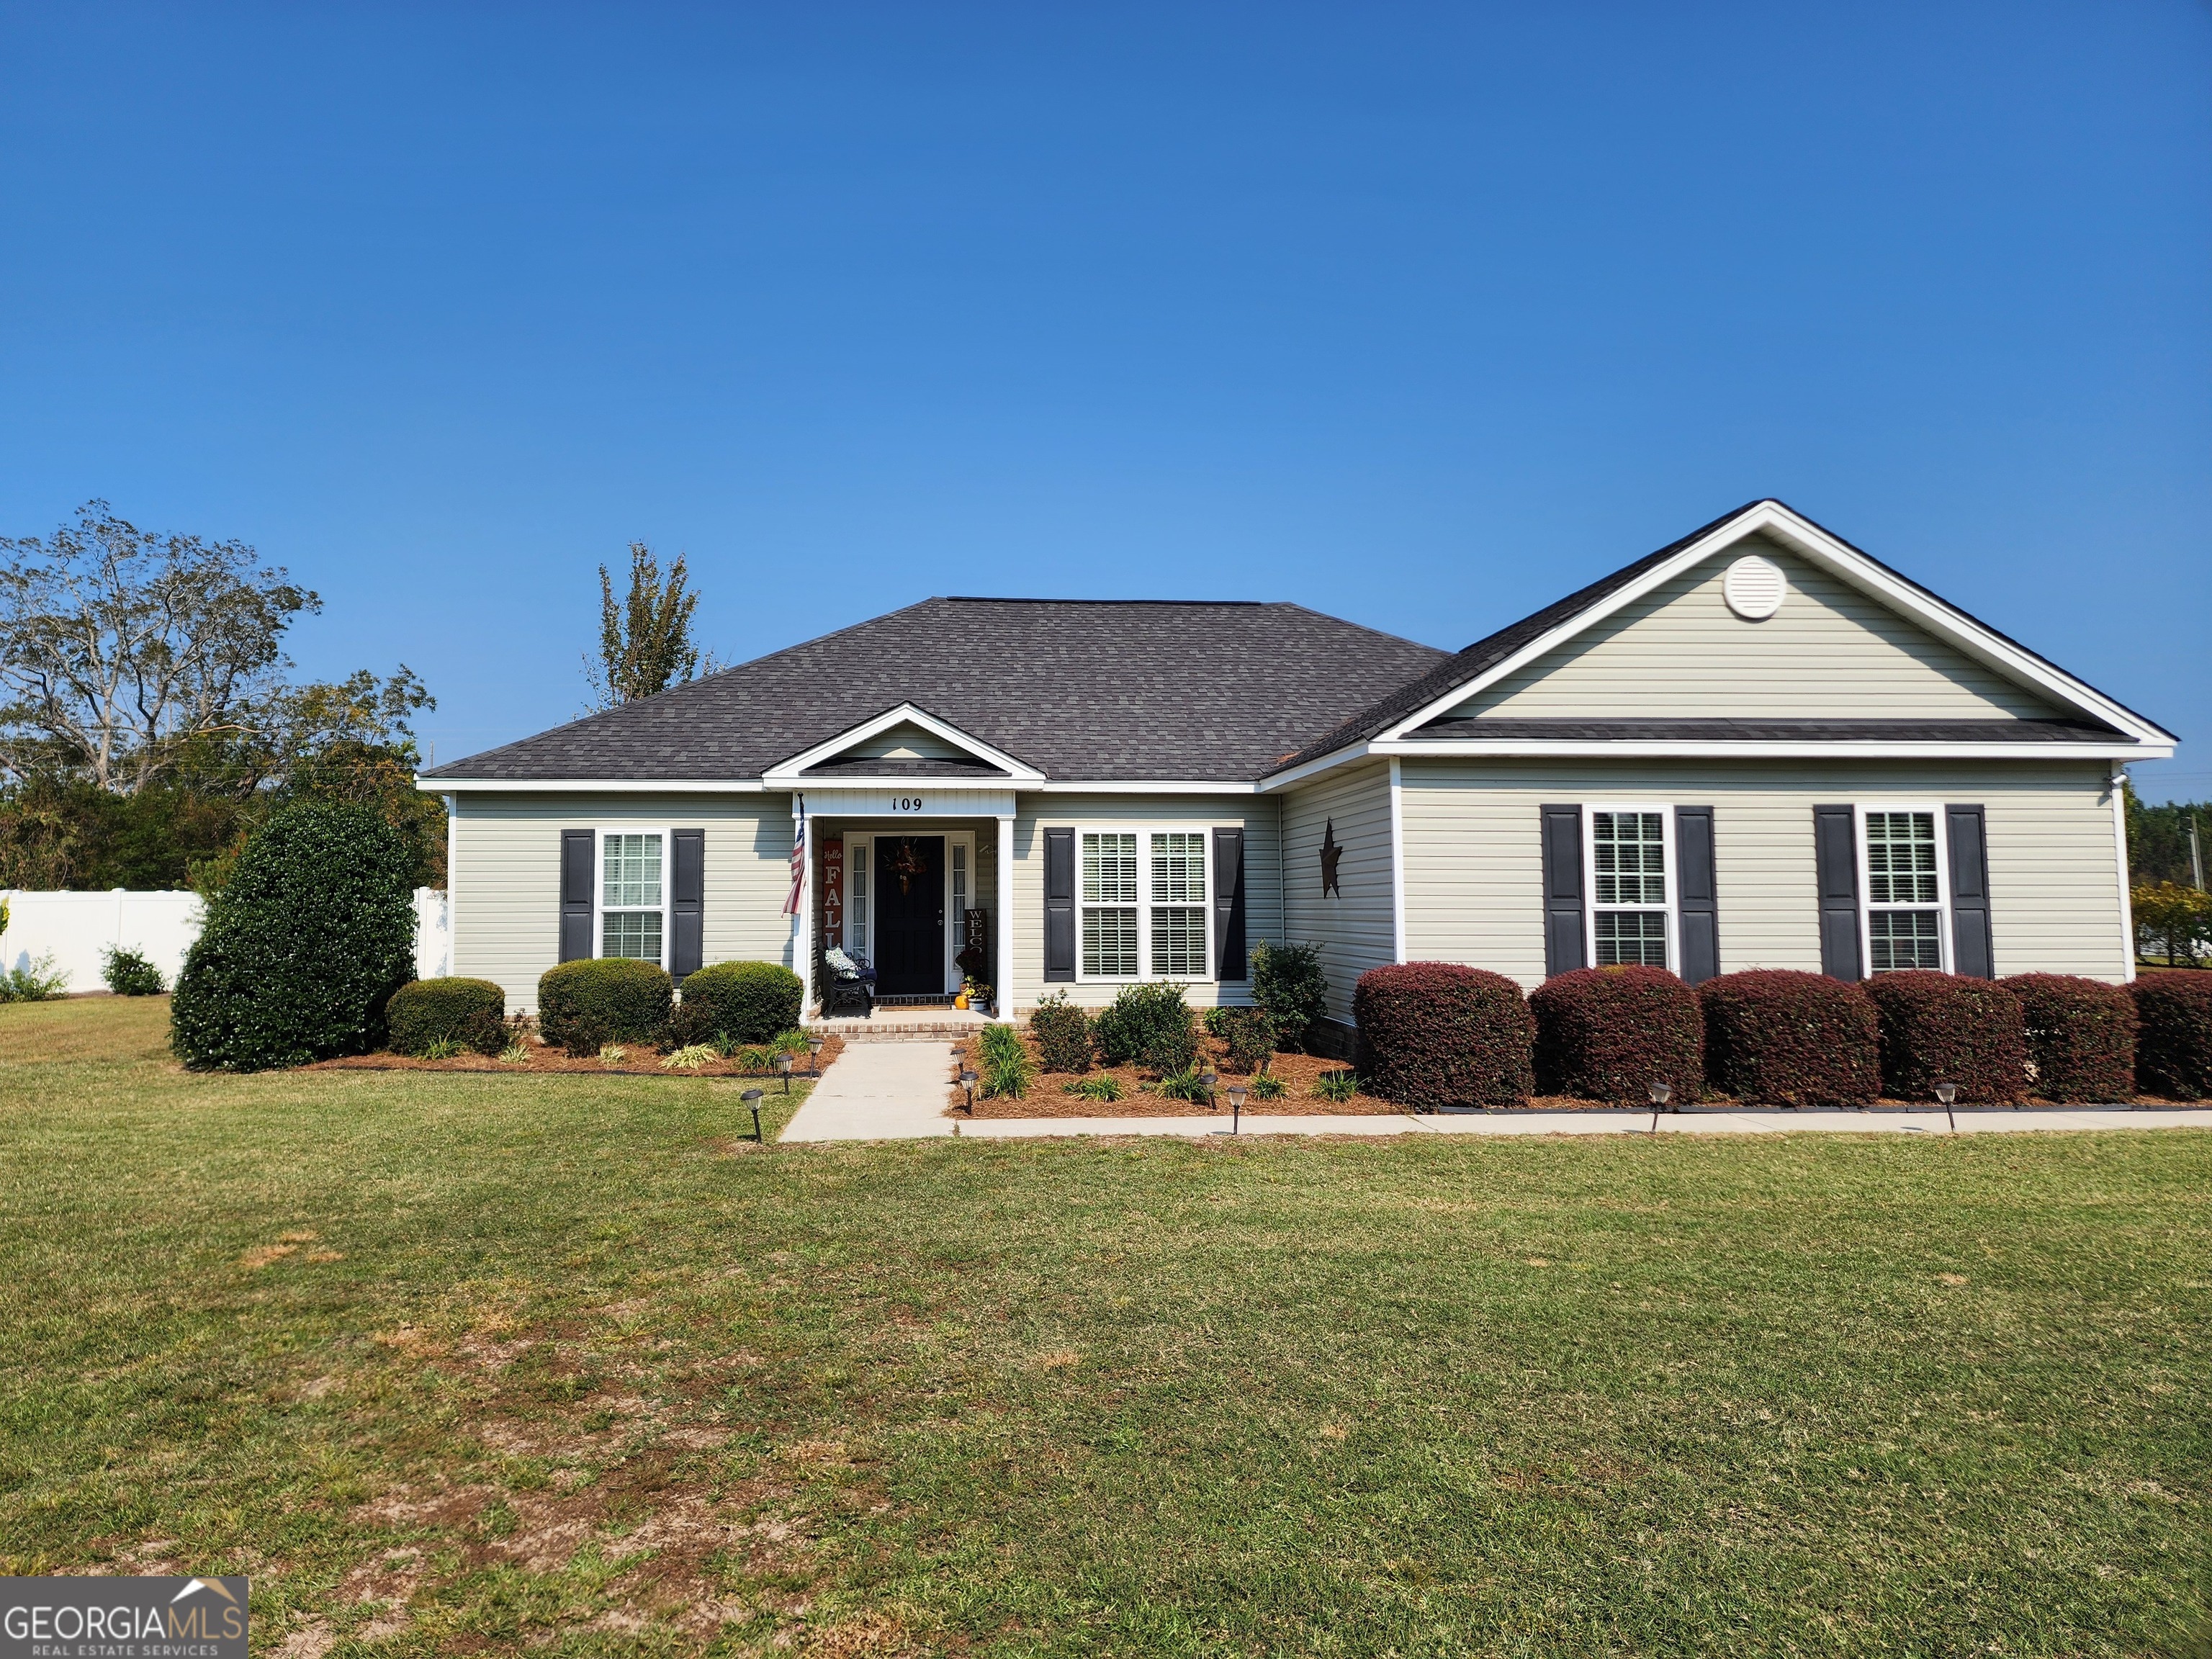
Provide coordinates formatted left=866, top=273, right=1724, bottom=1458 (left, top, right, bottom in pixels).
left=1378, top=502, right=2175, bottom=761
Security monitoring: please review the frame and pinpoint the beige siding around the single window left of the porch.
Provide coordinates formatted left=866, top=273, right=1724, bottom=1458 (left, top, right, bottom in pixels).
left=454, top=792, right=792, bottom=1013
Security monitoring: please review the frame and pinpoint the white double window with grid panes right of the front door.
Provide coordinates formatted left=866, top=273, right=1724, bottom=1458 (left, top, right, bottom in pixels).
left=1077, top=830, right=1212, bottom=980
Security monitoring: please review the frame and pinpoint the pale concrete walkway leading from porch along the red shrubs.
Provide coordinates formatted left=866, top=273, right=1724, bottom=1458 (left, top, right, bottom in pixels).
left=783, top=1057, right=2212, bottom=1141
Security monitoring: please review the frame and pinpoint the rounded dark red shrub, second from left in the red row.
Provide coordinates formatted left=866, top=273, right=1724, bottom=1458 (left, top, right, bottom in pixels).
left=1529, top=966, right=1706, bottom=1106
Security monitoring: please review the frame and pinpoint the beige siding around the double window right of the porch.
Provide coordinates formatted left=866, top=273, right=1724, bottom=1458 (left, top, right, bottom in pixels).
left=1011, top=794, right=1283, bottom=1013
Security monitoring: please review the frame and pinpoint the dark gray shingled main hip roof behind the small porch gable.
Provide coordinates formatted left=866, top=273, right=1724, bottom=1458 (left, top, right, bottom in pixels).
left=423, top=600, right=1447, bottom=783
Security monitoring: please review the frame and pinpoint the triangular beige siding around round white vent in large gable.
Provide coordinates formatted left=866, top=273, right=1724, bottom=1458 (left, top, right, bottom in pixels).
left=1453, top=537, right=2057, bottom=719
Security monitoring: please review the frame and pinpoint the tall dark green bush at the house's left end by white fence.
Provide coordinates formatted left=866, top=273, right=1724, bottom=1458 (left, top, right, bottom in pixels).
left=171, top=803, right=416, bottom=1071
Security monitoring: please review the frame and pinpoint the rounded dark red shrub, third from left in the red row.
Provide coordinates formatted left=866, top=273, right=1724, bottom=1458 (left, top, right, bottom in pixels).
left=1696, top=969, right=1882, bottom=1106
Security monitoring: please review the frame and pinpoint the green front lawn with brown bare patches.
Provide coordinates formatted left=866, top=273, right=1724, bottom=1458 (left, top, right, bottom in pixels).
left=13, top=1002, right=2212, bottom=1659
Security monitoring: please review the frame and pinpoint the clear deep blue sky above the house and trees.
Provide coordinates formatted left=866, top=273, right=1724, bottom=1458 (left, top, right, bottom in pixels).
left=0, top=0, right=2212, bottom=796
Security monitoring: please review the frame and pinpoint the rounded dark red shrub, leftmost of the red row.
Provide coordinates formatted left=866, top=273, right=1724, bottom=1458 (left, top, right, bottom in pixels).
left=1352, top=962, right=1535, bottom=1106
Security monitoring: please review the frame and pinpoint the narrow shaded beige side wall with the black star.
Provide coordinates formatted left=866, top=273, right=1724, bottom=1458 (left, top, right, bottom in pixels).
left=1283, top=763, right=1395, bottom=1022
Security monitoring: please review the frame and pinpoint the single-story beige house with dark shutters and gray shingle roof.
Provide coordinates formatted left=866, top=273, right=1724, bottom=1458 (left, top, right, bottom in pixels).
left=421, top=500, right=2175, bottom=1039
